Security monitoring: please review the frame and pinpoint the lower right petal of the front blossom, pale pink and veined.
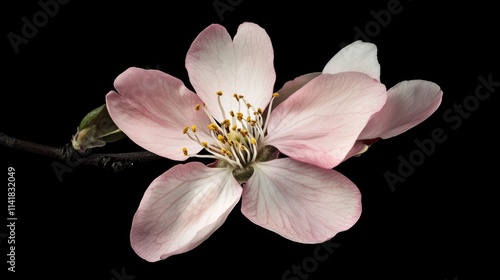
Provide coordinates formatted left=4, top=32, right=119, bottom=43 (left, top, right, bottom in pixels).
left=241, top=158, right=361, bottom=243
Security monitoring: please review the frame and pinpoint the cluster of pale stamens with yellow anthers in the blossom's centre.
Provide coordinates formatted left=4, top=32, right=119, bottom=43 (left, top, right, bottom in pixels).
left=182, top=91, right=278, bottom=173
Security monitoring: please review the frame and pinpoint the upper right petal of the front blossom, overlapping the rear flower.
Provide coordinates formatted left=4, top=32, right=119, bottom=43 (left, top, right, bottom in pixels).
left=265, top=72, right=387, bottom=168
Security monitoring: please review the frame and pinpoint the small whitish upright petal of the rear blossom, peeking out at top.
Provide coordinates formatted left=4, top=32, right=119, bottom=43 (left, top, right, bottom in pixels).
left=323, top=40, right=380, bottom=81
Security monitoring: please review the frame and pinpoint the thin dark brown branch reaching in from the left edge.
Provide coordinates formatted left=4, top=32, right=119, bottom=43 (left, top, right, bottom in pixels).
left=0, top=132, right=162, bottom=172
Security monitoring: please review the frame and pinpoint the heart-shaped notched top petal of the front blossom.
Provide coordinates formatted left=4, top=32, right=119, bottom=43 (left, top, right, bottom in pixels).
left=186, top=22, right=276, bottom=121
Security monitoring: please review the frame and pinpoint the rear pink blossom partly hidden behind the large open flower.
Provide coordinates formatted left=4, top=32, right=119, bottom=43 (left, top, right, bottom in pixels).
left=278, top=41, right=443, bottom=159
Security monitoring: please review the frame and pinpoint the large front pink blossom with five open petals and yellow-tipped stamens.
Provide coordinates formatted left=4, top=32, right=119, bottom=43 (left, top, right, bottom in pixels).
left=106, top=23, right=386, bottom=262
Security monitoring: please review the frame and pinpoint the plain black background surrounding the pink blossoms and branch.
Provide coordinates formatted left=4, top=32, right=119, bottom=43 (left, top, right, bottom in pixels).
left=0, top=0, right=500, bottom=280
